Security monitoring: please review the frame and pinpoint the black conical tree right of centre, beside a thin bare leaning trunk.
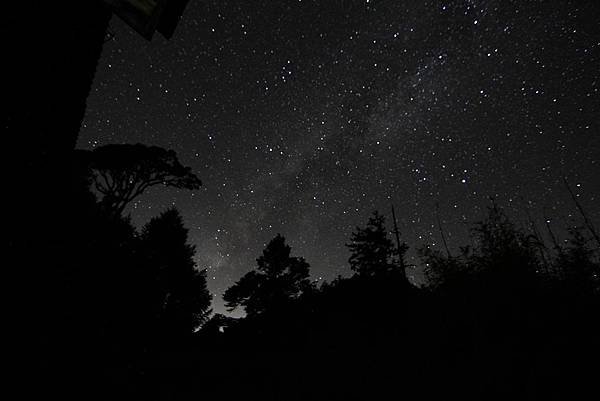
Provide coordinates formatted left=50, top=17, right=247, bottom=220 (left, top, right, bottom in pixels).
left=346, top=211, right=406, bottom=276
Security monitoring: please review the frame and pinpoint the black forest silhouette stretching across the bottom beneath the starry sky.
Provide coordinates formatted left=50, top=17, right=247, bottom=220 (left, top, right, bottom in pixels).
left=34, top=144, right=600, bottom=400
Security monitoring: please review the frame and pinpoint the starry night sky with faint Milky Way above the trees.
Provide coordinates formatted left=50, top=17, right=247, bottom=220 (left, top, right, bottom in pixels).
left=78, top=0, right=600, bottom=312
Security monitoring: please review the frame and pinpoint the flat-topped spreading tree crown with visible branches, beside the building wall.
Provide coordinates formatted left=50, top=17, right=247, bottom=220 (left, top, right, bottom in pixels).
left=81, top=143, right=202, bottom=214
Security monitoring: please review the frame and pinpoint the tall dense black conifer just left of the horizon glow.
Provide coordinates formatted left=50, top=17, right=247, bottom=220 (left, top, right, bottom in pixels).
left=141, top=209, right=211, bottom=338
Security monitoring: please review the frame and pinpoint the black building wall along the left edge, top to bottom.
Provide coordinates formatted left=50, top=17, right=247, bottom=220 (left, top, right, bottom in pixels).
left=1, top=0, right=111, bottom=398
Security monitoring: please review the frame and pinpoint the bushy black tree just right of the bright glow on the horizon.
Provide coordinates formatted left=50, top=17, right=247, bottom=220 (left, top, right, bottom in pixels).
left=223, top=234, right=313, bottom=317
